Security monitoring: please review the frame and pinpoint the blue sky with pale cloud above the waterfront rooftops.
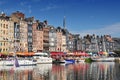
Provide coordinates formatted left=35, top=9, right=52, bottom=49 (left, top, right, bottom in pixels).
left=0, top=0, right=120, bottom=37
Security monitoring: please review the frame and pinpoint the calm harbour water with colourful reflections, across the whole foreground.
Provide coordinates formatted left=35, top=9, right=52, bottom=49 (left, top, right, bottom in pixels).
left=0, top=62, right=120, bottom=80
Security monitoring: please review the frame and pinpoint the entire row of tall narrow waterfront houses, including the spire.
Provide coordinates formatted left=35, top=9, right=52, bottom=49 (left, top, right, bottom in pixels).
left=0, top=11, right=120, bottom=54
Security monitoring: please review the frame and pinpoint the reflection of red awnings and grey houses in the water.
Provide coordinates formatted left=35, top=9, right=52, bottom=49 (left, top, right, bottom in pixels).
left=52, top=62, right=120, bottom=80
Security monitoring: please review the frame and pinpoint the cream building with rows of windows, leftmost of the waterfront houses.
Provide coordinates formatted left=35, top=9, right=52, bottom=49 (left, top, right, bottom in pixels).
left=0, top=14, right=14, bottom=54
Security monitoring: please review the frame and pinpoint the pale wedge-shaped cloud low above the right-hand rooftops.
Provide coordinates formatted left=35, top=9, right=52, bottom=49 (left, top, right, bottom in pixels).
left=71, top=23, right=120, bottom=37
